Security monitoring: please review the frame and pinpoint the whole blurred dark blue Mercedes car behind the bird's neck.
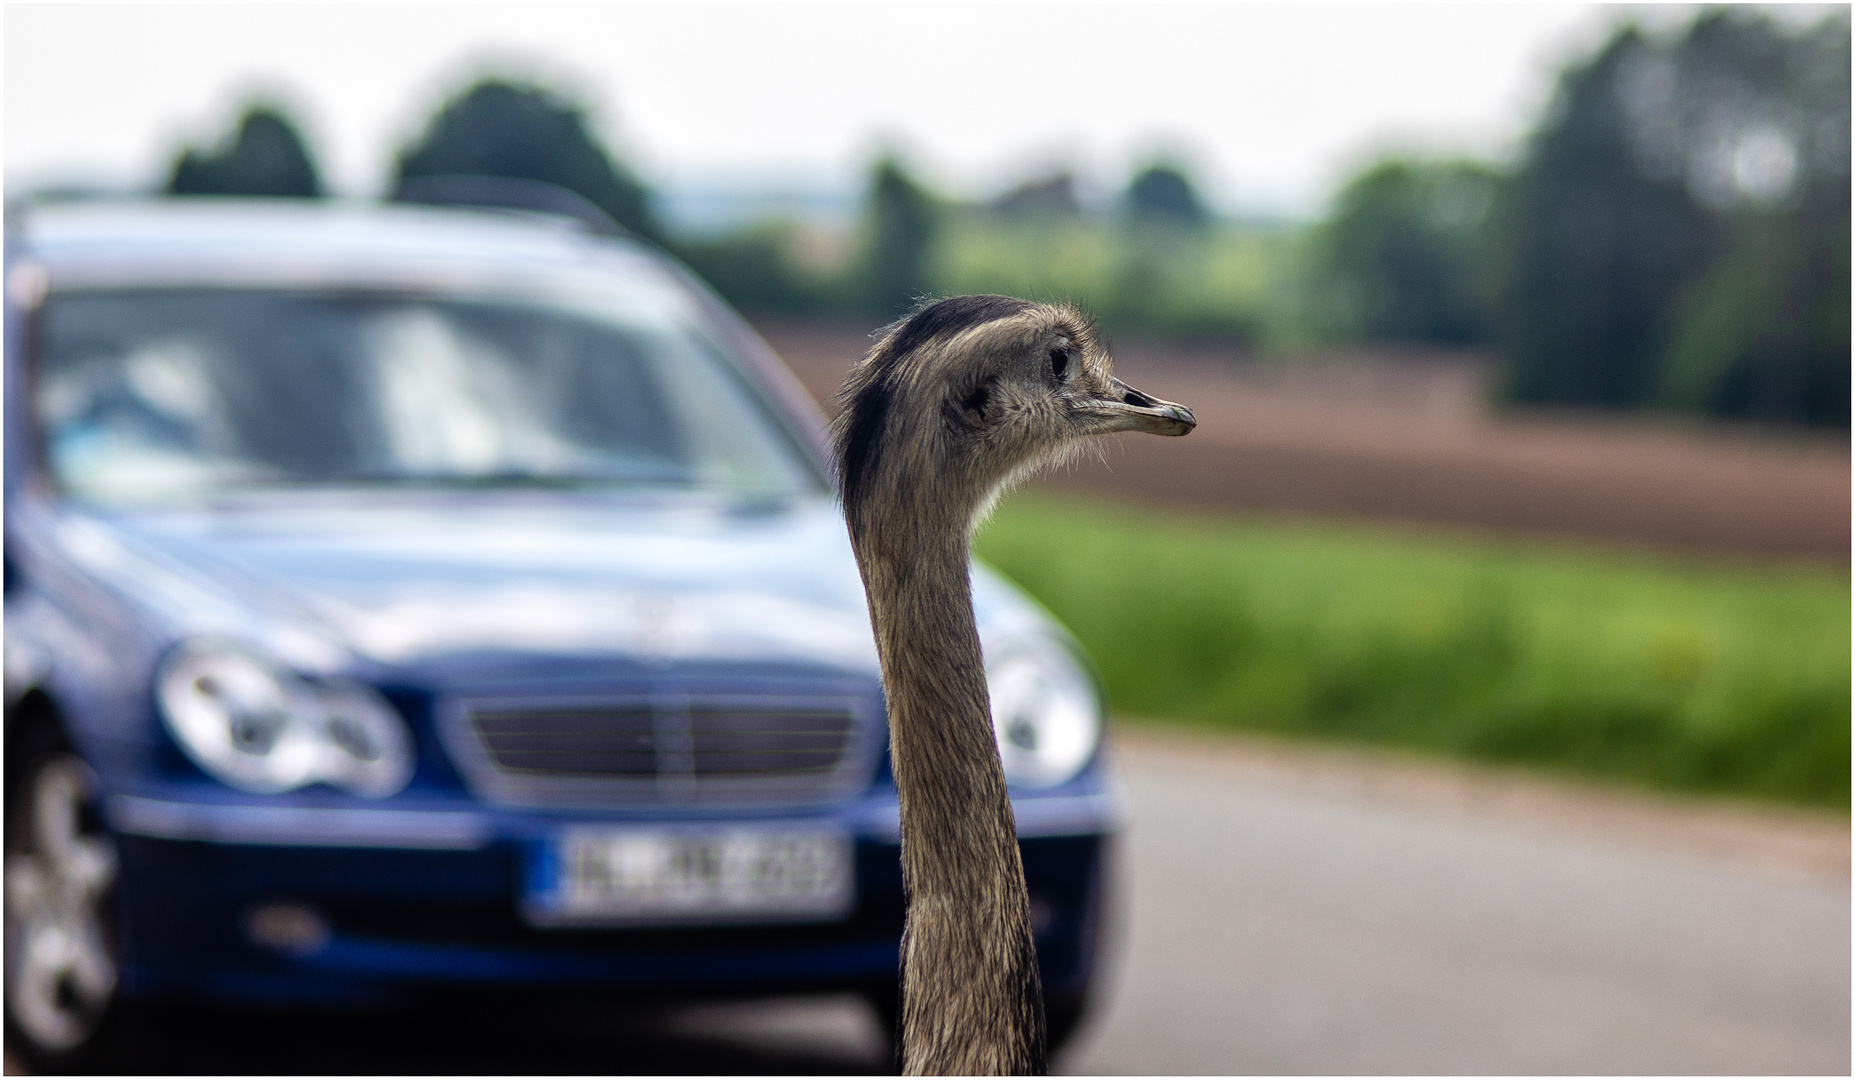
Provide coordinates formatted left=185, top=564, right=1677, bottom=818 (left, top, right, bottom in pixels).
left=6, top=200, right=1120, bottom=1067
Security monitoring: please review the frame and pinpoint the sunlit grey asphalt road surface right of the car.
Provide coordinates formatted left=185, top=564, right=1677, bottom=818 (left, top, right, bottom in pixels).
left=1061, top=746, right=1849, bottom=1074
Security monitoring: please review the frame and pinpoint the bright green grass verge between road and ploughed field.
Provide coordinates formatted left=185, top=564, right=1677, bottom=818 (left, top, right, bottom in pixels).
left=976, top=495, right=1849, bottom=811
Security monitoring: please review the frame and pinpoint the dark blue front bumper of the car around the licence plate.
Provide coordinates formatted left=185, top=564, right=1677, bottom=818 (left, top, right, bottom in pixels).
left=106, top=785, right=1119, bottom=1004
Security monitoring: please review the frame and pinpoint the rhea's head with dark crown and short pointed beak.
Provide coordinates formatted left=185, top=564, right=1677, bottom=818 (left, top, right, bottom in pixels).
left=833, top=297, right=1198, bottom=533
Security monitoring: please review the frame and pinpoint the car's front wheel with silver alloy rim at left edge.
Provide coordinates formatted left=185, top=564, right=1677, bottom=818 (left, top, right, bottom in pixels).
left=6, top=733, right=121, bottom=1069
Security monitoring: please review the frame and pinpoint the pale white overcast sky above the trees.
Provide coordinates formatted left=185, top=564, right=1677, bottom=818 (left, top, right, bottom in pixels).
left=6, top=4, right=1706, bottom=213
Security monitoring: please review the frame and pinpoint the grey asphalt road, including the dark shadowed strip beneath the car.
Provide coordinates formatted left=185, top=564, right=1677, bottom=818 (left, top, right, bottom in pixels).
left=7, top=737, right=1849, bottom=1074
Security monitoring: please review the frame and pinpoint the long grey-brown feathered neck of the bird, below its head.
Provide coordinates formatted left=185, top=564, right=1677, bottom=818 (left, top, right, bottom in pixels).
left=851, top=499, right=1044, bottom=1074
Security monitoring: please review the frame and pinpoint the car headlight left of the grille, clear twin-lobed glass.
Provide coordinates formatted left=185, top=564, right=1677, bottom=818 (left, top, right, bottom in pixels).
left=156, top=640, right=412, bottom=798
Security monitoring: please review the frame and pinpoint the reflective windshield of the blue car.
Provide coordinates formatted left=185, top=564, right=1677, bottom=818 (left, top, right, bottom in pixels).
left=33, top=289, right=818, bottom=503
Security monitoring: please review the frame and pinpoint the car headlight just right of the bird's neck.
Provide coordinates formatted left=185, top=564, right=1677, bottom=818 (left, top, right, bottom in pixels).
left=985, top=640, right=1102, bottom=787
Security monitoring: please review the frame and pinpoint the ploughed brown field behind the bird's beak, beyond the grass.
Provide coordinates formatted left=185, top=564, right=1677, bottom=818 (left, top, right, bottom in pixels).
left=757, top=323, right=1849, bottom=564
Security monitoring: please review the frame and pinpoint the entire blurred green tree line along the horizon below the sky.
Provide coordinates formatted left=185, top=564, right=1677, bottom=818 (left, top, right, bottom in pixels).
left=167, top=9, right=1849, bottom=427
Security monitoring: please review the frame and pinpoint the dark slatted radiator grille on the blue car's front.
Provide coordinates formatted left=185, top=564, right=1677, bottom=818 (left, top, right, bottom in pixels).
left=447, top=698, right=874, bottom=805
